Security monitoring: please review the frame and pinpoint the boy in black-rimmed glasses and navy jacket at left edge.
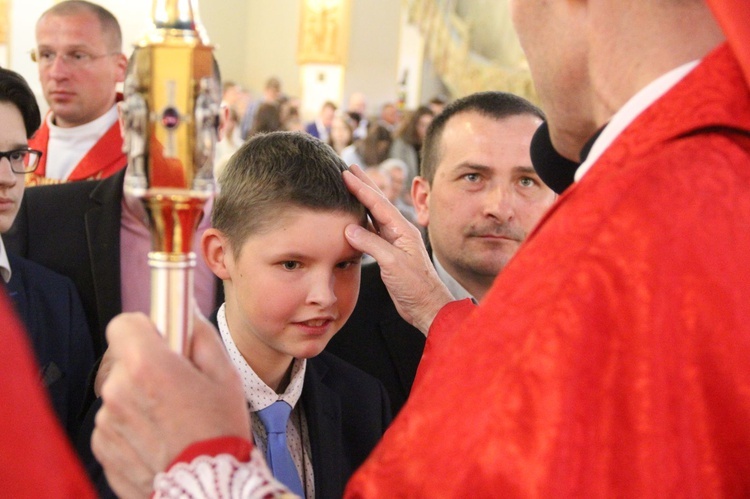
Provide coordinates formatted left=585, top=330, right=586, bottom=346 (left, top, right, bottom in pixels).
left=0, top=69, right=94, bottom=446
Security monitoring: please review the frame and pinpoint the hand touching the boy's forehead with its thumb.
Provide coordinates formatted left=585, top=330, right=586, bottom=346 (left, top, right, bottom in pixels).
left=344, top=165, right=453, bottom=335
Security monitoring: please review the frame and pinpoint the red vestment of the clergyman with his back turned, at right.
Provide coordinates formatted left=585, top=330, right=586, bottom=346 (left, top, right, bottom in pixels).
left=346, top=47, right=750, bottom=498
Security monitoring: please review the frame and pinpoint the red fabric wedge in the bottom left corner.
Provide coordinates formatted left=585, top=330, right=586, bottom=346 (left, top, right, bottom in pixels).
left=0, top=290, right=95, bottom=498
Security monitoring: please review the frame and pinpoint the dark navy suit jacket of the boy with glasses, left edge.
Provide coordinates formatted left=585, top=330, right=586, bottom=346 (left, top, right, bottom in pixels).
left=0, top=254, right=94, bottom=441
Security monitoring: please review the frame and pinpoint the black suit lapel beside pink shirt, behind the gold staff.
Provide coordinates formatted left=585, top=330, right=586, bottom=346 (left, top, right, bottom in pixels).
left=85, top=170, right=125, bottom=338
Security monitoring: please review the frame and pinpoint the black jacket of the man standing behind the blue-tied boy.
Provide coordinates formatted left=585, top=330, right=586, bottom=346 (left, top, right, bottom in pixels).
left=326, top=263, right=426, bottom=416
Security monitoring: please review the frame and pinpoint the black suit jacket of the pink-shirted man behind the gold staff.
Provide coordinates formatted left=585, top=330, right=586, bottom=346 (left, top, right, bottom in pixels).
left=3, top=170, right=224, bottom=357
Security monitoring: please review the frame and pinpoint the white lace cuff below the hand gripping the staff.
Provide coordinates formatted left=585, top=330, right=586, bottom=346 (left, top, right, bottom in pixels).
left=153, top=449, right=296, bottom=499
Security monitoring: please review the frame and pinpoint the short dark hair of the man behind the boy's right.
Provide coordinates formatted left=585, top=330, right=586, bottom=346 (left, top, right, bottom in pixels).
left=419, top=92, right=545, bottom=184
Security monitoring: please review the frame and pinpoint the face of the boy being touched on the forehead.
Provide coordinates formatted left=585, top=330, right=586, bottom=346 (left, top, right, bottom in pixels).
left=224, top=208, right=362, bottom=366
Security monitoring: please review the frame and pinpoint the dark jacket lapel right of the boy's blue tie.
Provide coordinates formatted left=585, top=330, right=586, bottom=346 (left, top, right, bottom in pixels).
left=302, top=358, right=345, bottom=498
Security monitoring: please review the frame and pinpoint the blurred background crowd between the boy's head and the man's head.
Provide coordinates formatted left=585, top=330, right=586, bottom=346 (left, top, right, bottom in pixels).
left=215, top=77, right=447, bottom=232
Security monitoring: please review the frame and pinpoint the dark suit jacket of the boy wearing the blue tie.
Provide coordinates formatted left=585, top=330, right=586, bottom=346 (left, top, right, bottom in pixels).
left=79, top=314, right=391, bottom=499
